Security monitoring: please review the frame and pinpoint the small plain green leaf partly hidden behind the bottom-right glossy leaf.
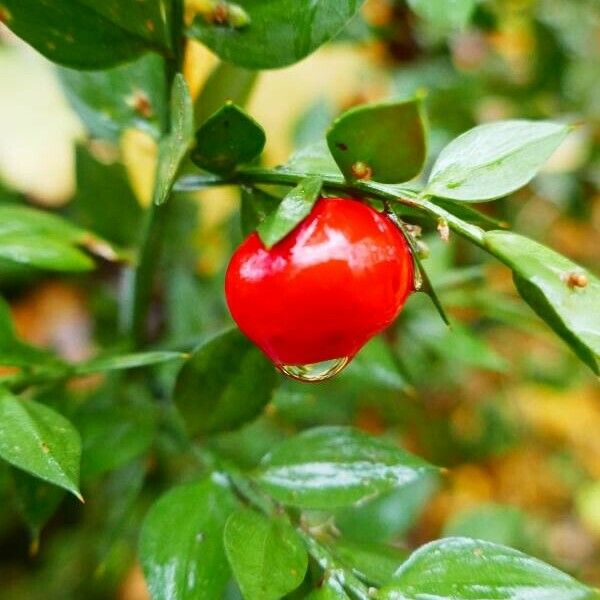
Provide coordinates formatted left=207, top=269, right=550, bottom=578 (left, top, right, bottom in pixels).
left=331, top=539, right=407, bottom=587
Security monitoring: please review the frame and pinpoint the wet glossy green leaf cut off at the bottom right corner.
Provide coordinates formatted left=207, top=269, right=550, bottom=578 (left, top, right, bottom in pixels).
left=378, top=538, right=598, bottom=600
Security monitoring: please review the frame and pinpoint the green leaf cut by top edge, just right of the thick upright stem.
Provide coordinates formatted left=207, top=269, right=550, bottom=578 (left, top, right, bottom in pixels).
left=188, top=0, right=363, bottom=69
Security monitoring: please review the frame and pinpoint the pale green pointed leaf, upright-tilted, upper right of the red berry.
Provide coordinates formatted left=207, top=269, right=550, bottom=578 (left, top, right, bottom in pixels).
left=425, top=120, right=571, bottom=202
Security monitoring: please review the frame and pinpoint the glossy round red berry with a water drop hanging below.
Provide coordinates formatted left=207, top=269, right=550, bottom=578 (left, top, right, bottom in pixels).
left=225, top=198, right=414, bottom=366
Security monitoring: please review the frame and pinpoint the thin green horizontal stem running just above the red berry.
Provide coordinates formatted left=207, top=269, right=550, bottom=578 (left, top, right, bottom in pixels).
left=175, top=167, right=484, bottom=247
